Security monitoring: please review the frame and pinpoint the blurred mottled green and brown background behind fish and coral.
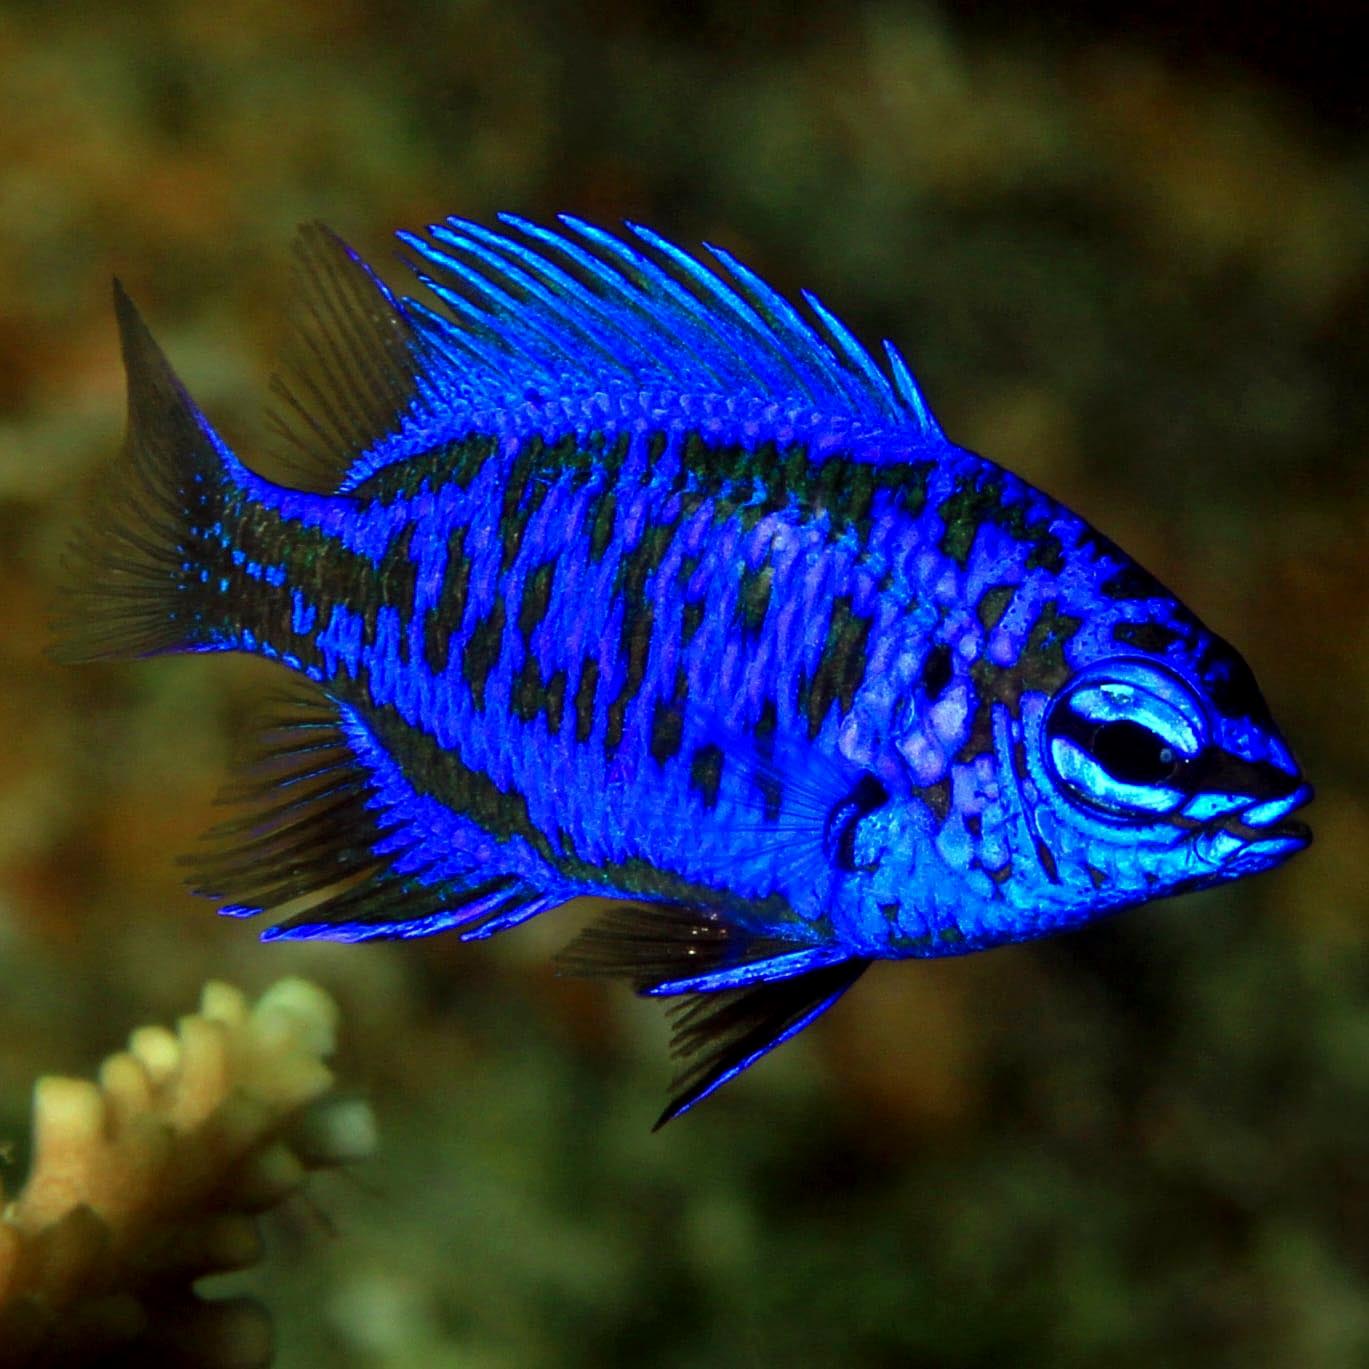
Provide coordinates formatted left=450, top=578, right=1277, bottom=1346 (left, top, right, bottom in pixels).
left=0, top=0, right=1369, bottom=1369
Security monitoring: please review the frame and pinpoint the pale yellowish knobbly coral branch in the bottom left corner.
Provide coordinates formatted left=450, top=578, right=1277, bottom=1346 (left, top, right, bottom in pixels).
left=0, top=979, right=375, bottom=1369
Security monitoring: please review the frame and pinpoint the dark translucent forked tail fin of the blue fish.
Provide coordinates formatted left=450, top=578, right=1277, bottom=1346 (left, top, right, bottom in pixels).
left=52, top=281, right=235, bottom=661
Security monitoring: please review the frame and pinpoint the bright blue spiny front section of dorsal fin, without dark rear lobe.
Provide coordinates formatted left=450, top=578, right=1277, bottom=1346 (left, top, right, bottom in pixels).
left=400, top=214, right=941, bottom=437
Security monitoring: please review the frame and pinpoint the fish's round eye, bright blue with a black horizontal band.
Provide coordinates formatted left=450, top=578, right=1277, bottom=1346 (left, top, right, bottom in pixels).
left=1045, top=660, right=1207, bottom=816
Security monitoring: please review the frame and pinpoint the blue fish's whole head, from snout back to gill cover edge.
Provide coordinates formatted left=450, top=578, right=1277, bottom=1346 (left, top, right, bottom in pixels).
left=848, top=594, right=1313, bottom=956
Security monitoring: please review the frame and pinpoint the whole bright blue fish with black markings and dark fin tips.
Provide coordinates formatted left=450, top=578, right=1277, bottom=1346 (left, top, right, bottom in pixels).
left=63, top=215, right=1312, bottom=1125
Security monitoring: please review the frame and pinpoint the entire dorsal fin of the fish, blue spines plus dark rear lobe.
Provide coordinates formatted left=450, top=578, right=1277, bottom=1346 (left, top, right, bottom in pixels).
left=272, top=215, right=945, bottom=490
